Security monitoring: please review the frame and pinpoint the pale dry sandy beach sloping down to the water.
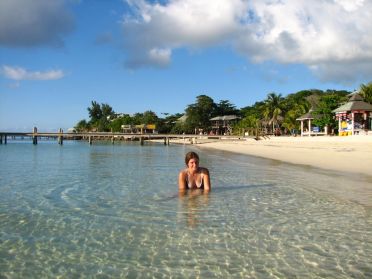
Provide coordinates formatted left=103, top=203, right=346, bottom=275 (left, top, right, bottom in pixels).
left=192, top=135, right=372, bottom=176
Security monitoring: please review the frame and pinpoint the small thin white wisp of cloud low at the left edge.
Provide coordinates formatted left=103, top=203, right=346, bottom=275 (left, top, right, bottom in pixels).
left=1, top=65, right=65, bottom=81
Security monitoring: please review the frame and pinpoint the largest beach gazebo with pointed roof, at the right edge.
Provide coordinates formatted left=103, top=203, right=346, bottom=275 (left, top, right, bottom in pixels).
left=333, top=92, right=372, bottom=136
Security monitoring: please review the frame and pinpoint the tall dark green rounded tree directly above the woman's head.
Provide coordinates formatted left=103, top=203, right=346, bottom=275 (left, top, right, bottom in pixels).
left=185, top=95, right=216, bottom=131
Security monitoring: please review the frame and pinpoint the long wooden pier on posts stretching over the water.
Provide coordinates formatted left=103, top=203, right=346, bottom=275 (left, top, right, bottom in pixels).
left=0, top=128, right=241, bottom=145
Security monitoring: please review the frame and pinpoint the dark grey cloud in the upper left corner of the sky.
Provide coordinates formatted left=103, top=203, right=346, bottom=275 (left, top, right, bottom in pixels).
left=0, top=0, right=74, bottom=47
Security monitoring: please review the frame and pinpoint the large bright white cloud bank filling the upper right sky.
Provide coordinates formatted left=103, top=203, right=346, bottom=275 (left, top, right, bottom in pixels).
left=122, top=0, right=372, bottom=82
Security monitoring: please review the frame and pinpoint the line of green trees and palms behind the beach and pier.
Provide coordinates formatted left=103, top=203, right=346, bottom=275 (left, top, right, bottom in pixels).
left=75, top=82, right=372, bottom=135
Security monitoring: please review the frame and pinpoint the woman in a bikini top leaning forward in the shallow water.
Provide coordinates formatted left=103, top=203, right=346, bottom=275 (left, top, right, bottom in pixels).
left=178, top=152, right=211, bottom=191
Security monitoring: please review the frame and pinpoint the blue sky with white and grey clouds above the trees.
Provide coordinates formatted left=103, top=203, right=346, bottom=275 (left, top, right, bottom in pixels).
left=0, top=0, right=372, bottom=132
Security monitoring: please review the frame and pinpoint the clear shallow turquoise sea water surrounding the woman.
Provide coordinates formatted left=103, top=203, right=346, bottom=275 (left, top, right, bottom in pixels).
left=0, top=140, right=372, bottom=278
